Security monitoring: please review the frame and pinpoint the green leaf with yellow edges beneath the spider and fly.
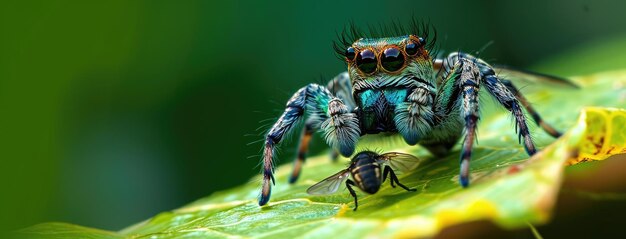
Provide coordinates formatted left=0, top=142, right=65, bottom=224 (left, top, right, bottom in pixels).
left=21, top=71, right=626, bottom=238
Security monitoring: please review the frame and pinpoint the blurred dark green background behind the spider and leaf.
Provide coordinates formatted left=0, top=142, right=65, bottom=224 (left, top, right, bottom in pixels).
left=0, top=0, right=626, bottom=233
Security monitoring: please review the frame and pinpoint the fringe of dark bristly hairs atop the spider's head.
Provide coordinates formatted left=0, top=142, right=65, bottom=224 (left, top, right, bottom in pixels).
left=333, top=17, right=438, bottom=61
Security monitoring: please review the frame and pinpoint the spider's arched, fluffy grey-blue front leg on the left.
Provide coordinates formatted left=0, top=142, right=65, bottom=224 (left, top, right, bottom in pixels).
left=259, top=84, right=360, bottom=206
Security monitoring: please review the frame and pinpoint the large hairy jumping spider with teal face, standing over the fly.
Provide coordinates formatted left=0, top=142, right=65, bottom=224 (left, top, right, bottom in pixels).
left=259, top=23, right=563, bottom=205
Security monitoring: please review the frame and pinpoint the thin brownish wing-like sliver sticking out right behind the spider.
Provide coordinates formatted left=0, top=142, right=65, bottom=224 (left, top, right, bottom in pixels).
left=494, top=65, right=578, bottom=88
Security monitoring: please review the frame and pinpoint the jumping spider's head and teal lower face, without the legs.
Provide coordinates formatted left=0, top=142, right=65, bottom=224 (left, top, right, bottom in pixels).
left=346, top=35, right=436, bottom=145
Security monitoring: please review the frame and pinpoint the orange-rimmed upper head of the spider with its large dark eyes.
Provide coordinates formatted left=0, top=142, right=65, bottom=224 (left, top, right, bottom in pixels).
left=343, top=35, right=433, bottom=91
